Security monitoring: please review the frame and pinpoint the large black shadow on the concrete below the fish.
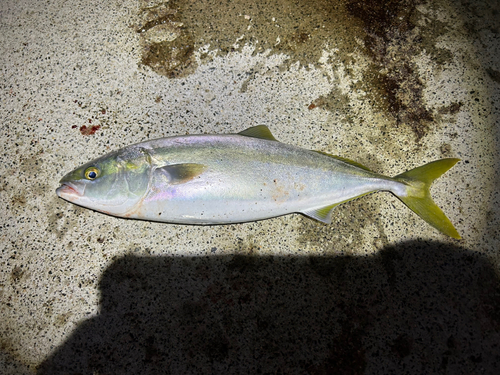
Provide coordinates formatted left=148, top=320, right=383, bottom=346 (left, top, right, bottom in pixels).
left=38, top=242, right=500, bottom=374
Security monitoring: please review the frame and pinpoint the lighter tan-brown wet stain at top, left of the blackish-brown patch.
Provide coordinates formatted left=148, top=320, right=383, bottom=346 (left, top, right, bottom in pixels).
left=133, top=0, right=354, bottom=78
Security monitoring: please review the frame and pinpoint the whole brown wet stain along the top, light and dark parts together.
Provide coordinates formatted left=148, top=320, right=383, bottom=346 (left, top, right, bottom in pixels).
left=133, top=0, right=460, bottom=143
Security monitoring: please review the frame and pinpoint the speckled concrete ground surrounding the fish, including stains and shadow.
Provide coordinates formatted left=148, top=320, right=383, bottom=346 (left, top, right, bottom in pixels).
left=0, top=0, right=500, bottom=374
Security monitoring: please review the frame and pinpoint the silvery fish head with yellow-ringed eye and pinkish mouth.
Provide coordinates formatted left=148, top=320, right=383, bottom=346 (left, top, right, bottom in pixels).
left=56, top=146, right=152, bottom=216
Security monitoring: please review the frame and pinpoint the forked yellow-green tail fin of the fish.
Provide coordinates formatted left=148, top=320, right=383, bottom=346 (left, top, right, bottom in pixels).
left=394, top=158, right=461, bottom=239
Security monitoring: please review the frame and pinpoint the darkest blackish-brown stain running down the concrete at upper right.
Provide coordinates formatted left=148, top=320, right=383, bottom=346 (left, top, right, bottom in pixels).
left=346, top=0, right=440, bottom=142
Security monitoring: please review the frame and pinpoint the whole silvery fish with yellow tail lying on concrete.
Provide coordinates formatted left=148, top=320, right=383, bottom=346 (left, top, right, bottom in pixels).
left=56, top=125, right=460, bottom=239
